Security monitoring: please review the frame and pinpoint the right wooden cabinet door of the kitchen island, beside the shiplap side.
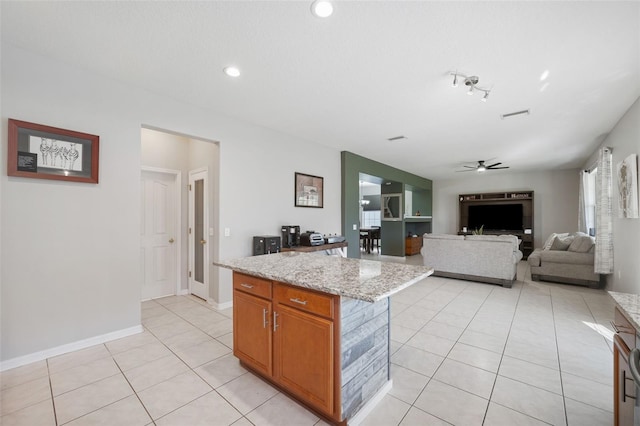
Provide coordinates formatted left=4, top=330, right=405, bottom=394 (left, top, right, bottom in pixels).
left=273, top=304, right=334, bottom=415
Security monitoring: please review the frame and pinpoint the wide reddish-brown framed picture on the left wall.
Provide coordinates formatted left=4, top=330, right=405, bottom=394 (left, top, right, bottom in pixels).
left=7, top=118, right=100, bottom=183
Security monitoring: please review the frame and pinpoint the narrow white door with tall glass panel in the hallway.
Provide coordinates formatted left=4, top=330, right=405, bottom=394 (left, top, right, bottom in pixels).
left=189, top=169, right=209, bottom=300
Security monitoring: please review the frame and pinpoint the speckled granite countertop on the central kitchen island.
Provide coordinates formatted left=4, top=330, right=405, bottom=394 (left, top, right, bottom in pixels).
left=214, top=252, right=433, bottom=302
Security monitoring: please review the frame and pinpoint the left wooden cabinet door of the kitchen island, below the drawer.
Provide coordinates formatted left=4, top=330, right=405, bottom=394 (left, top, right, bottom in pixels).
left=233, top=290, right=273, bottom=377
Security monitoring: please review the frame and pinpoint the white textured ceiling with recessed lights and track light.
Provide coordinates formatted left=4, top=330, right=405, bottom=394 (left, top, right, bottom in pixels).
left=0, top=1, right=640, bottom=179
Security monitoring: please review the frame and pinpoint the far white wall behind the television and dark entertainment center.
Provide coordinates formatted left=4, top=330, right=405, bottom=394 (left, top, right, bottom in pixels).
left=433, top=170, right=579, bottom=247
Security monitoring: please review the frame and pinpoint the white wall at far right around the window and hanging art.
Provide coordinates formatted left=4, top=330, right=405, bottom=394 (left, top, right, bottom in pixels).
left=584, top=98, right=640, bottom=294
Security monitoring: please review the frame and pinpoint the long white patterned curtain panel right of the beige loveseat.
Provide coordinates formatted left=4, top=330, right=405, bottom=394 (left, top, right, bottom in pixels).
left=594, top=148, right=613, bottom=274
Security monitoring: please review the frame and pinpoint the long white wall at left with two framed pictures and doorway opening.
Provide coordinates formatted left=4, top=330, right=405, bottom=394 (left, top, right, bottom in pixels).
left=0, top=43, right=341, bottom=366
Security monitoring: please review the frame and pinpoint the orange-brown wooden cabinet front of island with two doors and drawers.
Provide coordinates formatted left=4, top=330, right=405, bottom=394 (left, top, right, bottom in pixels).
left=233, top=272, right=341, bottom=419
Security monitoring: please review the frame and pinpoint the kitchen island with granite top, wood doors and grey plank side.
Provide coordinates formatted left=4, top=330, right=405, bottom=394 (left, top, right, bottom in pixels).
left=216, top=252, right=433, bottom=424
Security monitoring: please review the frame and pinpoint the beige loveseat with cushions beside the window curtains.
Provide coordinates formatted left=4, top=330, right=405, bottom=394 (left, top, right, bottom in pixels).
left=528, top=232, right=603, bottom=288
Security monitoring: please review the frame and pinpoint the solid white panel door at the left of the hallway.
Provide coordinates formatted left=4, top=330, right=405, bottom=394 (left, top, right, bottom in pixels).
left=140, top=170, right=177, bottom=300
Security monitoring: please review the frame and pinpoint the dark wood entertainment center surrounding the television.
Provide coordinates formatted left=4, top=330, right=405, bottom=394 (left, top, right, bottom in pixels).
left=458, top=191, right=533, bottom=259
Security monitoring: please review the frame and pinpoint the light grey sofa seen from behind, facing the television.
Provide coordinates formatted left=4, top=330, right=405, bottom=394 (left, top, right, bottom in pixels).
left=420, top=234, right=522, bottom=288
